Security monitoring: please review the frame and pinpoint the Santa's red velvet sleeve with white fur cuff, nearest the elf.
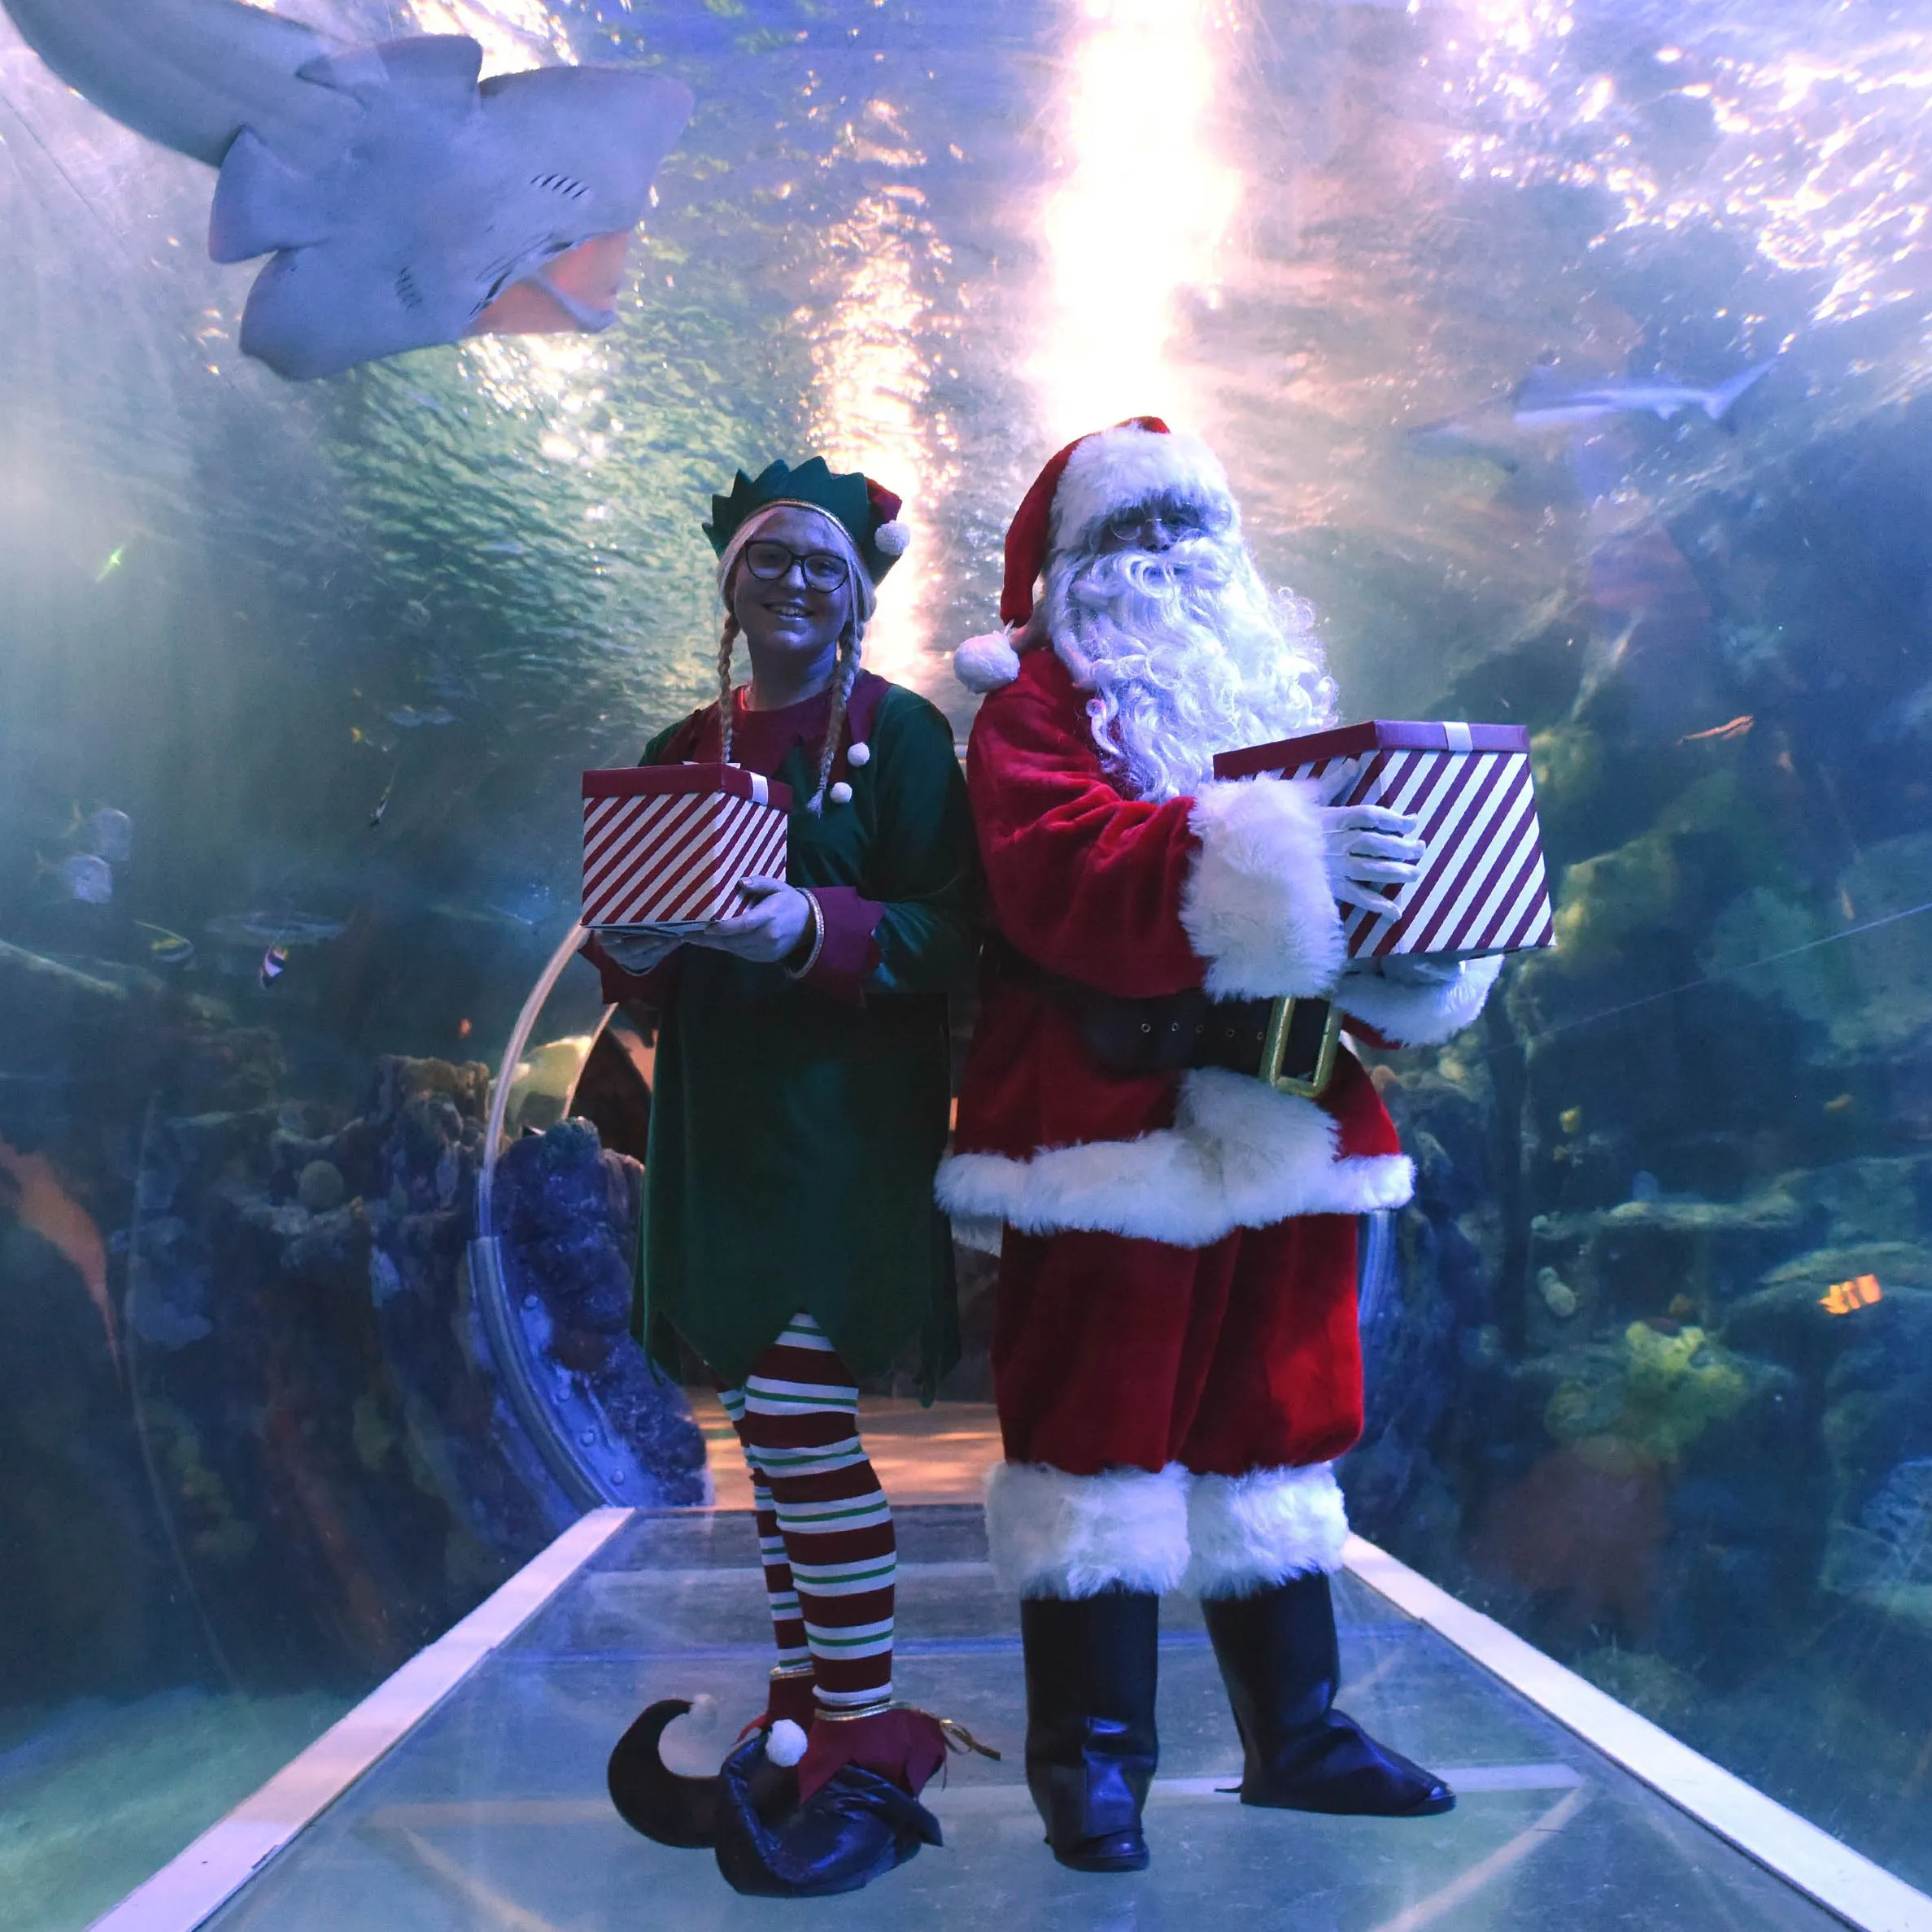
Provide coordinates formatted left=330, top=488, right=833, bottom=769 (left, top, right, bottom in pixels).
left=966, top=651, right=1343, bottom=999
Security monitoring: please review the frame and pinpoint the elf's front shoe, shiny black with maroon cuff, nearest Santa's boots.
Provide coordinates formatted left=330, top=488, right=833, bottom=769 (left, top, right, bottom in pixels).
left=717, top=1708, right=995, bottom=1899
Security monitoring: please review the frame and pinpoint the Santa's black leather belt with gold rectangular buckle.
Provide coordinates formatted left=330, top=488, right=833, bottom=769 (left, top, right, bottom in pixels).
left=991, top=939, right=1341, bottom=1097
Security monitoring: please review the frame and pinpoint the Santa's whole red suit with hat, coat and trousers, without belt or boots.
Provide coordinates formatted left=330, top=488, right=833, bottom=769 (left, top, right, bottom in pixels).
left=937, top=421, right=1495, bottom=1598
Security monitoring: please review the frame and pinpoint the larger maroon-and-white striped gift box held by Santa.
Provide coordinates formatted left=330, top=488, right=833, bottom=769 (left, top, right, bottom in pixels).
left=1214, top=719, right=1555, bottom=958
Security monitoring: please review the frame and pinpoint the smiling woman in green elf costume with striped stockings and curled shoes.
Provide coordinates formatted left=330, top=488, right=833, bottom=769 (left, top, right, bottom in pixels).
left=587, top=456, right=979, bottom=1895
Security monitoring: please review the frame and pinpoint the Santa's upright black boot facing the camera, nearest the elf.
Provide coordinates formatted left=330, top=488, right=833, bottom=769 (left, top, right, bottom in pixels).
left=1020, top=1588, right=1161, bottom=1872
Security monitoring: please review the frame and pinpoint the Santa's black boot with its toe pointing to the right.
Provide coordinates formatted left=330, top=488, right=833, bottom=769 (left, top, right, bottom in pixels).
left=1202, top=1571, right=1454, bottom=1818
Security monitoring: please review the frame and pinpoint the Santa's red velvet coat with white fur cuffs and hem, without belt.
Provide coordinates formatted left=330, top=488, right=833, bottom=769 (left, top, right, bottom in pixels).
left=939, top=649, right=1494, bottom=1248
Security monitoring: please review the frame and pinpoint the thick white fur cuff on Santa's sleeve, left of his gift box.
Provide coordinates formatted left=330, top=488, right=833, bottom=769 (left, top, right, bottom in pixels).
left=1180, top=778, right=1366, bottom=1018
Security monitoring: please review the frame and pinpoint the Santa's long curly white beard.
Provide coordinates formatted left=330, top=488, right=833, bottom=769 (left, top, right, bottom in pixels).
left=1045, top=531, right=1335, bottom=800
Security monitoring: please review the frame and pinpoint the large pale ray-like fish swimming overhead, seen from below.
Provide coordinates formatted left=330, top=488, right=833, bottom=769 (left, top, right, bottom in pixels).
left=0, top=0, right=691, bottom=381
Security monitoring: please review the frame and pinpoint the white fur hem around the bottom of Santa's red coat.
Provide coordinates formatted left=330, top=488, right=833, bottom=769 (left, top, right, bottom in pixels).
left=933, top=1066, right=1416, bottom=1248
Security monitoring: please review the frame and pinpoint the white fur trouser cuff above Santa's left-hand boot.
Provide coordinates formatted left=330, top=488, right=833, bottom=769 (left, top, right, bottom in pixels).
left=985, top=1463, right=1188, bottom=1598
